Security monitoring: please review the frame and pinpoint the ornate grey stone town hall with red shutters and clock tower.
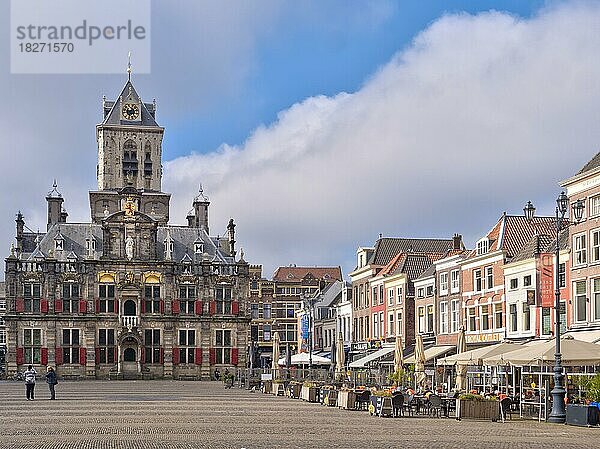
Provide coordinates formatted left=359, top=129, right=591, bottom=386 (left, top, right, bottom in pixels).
left=5, top=71, right=250, bottom=379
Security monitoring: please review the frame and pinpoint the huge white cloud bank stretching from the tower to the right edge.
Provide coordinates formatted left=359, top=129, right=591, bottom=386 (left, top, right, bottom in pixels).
left=165, top=3, right=600, bottom=275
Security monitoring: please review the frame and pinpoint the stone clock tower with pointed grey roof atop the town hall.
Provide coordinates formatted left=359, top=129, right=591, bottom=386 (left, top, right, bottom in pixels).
left=90, top=73, right=170, bottom=224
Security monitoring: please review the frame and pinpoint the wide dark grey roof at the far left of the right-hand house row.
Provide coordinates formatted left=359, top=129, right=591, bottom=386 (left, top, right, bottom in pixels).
left=368, top=237, right=453, bottom=265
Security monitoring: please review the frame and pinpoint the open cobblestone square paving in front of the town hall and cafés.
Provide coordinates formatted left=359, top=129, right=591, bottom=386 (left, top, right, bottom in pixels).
left=0, top=381, right=600, bottom=449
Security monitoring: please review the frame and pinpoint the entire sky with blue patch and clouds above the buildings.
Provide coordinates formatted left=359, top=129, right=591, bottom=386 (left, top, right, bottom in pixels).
left=0, top=0, right=600, bottom=277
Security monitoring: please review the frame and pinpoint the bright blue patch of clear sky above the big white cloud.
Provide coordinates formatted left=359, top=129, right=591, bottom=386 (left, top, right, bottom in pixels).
left=163, top=0, right=557, bottom=158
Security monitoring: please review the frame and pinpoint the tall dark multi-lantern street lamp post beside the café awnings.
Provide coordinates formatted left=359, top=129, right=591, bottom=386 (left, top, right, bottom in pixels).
left=523, top=192, right=585, bottom=424
